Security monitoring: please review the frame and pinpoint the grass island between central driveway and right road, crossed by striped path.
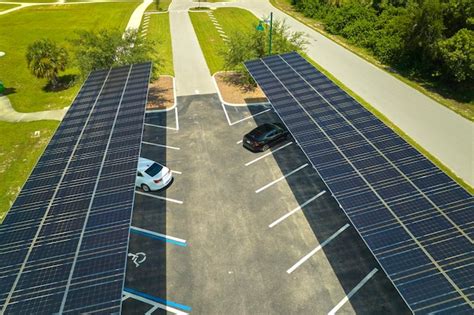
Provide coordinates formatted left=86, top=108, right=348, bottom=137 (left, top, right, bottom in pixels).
left=189, top=8, right=258, bottom=74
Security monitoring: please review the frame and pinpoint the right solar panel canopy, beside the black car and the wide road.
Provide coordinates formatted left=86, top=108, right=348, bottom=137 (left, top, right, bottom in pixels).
left=246, top=53, right=474, bottom=314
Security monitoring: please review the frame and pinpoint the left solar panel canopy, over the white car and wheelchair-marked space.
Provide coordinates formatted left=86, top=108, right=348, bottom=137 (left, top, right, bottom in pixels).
left=0, top=63, right=151, bottom=314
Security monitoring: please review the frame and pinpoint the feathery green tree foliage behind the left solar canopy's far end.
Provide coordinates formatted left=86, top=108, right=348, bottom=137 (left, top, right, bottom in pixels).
left=70, top=29, right=156, bottom=76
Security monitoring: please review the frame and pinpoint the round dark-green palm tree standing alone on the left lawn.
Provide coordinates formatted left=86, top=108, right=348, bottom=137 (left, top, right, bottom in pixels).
left=26, top=39, right=68, bottom=88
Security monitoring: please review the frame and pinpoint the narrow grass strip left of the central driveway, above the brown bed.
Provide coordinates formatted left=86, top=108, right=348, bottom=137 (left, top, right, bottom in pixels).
left=147, top=13, right=174, bottom=76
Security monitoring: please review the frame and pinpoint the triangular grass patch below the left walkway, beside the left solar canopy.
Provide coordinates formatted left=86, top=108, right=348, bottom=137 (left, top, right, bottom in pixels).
left=0, top=120, right=59, bottom=222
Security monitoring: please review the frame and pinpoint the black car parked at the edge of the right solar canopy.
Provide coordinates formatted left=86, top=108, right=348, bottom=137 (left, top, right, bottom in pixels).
left=242, top=123, right=289, bottom=152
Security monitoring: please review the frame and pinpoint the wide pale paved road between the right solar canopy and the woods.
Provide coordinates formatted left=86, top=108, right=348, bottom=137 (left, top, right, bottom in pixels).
left=174, top=0, right=474, bottom=186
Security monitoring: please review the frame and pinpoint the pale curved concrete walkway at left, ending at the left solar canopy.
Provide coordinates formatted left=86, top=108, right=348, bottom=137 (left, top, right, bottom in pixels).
left=0, top=95, right=69, bottom=122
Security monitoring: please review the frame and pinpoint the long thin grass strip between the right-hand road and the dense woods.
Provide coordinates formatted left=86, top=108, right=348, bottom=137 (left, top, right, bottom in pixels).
left=270, top=0, right=474, bottom=121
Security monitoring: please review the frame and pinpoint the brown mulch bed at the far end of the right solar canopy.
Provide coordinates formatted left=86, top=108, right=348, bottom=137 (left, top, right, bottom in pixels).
left=214, top=72, right=268, bottom=104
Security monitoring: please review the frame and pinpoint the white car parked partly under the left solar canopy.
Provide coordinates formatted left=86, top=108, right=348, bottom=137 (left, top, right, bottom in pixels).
left=135, top=158, right=173, bottom=191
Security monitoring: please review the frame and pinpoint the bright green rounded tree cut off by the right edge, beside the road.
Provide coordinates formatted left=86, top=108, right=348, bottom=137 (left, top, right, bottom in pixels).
left=438, top=28, right=474, bottom=82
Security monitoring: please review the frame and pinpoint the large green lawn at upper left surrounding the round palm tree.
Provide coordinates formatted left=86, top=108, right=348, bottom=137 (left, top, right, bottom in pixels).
left=0, top=3, right=138, bottom=112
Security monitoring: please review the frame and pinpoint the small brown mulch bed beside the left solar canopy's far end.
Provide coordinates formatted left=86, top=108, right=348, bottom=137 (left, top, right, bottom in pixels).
left=146, top=76, right=174, bottom=110
